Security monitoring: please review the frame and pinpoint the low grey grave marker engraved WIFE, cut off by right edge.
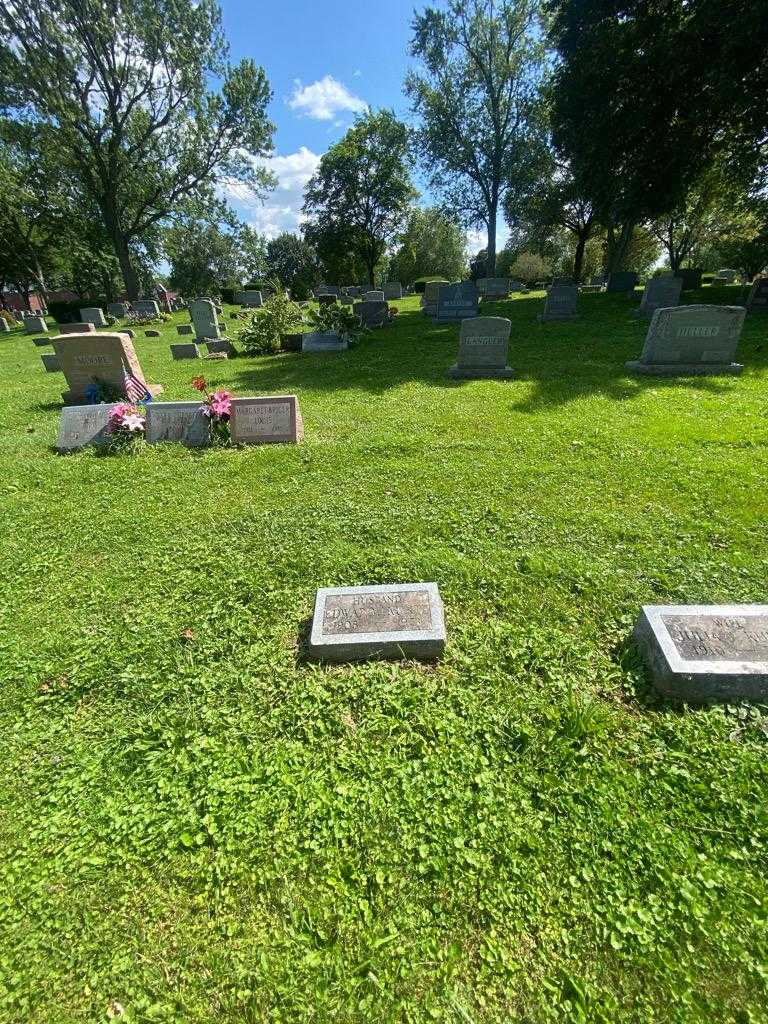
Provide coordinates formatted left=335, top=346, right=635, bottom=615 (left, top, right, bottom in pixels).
left=634, top=604, right=768, bottom=703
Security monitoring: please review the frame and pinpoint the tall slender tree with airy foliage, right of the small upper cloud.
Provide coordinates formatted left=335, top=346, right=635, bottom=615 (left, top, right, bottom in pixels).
left=406, top=0, right=544, bottom=276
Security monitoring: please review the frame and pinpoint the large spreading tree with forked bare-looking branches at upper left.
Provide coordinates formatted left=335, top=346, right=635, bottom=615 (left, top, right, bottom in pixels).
left=0, top=0, right=272, bottom=298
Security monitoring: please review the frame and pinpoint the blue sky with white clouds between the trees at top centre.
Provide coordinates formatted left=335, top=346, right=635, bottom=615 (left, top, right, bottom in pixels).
left=221, top=0, right=506, bottom=252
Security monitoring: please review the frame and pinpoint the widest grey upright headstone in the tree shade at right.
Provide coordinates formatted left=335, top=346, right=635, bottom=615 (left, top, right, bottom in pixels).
left=626, top=305, right=746, bottom=377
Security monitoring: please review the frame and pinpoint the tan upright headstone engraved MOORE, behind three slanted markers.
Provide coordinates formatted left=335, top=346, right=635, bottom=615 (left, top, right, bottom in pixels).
left=52, top=333, right=163, bottom=402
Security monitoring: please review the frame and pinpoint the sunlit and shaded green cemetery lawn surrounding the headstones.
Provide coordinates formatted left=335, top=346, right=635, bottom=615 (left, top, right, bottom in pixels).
left=0, top=288, right=768, bottom=1024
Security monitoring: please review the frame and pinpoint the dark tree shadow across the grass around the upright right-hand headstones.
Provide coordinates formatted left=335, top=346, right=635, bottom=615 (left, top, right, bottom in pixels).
left=233, top=289, right=768, bottom=413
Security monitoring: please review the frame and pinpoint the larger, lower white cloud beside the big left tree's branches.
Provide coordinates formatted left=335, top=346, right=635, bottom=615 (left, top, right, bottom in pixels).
left=223, top=145, right=321, bottom=239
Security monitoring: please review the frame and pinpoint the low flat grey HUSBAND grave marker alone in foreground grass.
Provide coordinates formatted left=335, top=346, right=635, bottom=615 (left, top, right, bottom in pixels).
left=309, top=583, right=445, bottom=662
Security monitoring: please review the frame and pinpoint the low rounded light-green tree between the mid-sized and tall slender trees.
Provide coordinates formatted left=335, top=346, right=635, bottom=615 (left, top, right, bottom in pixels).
left=390, top=207, right=467, bottom=285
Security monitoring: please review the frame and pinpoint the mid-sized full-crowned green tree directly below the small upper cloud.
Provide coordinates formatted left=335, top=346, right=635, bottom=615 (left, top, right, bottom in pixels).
left=304, top=111, right=417, bottom=284
